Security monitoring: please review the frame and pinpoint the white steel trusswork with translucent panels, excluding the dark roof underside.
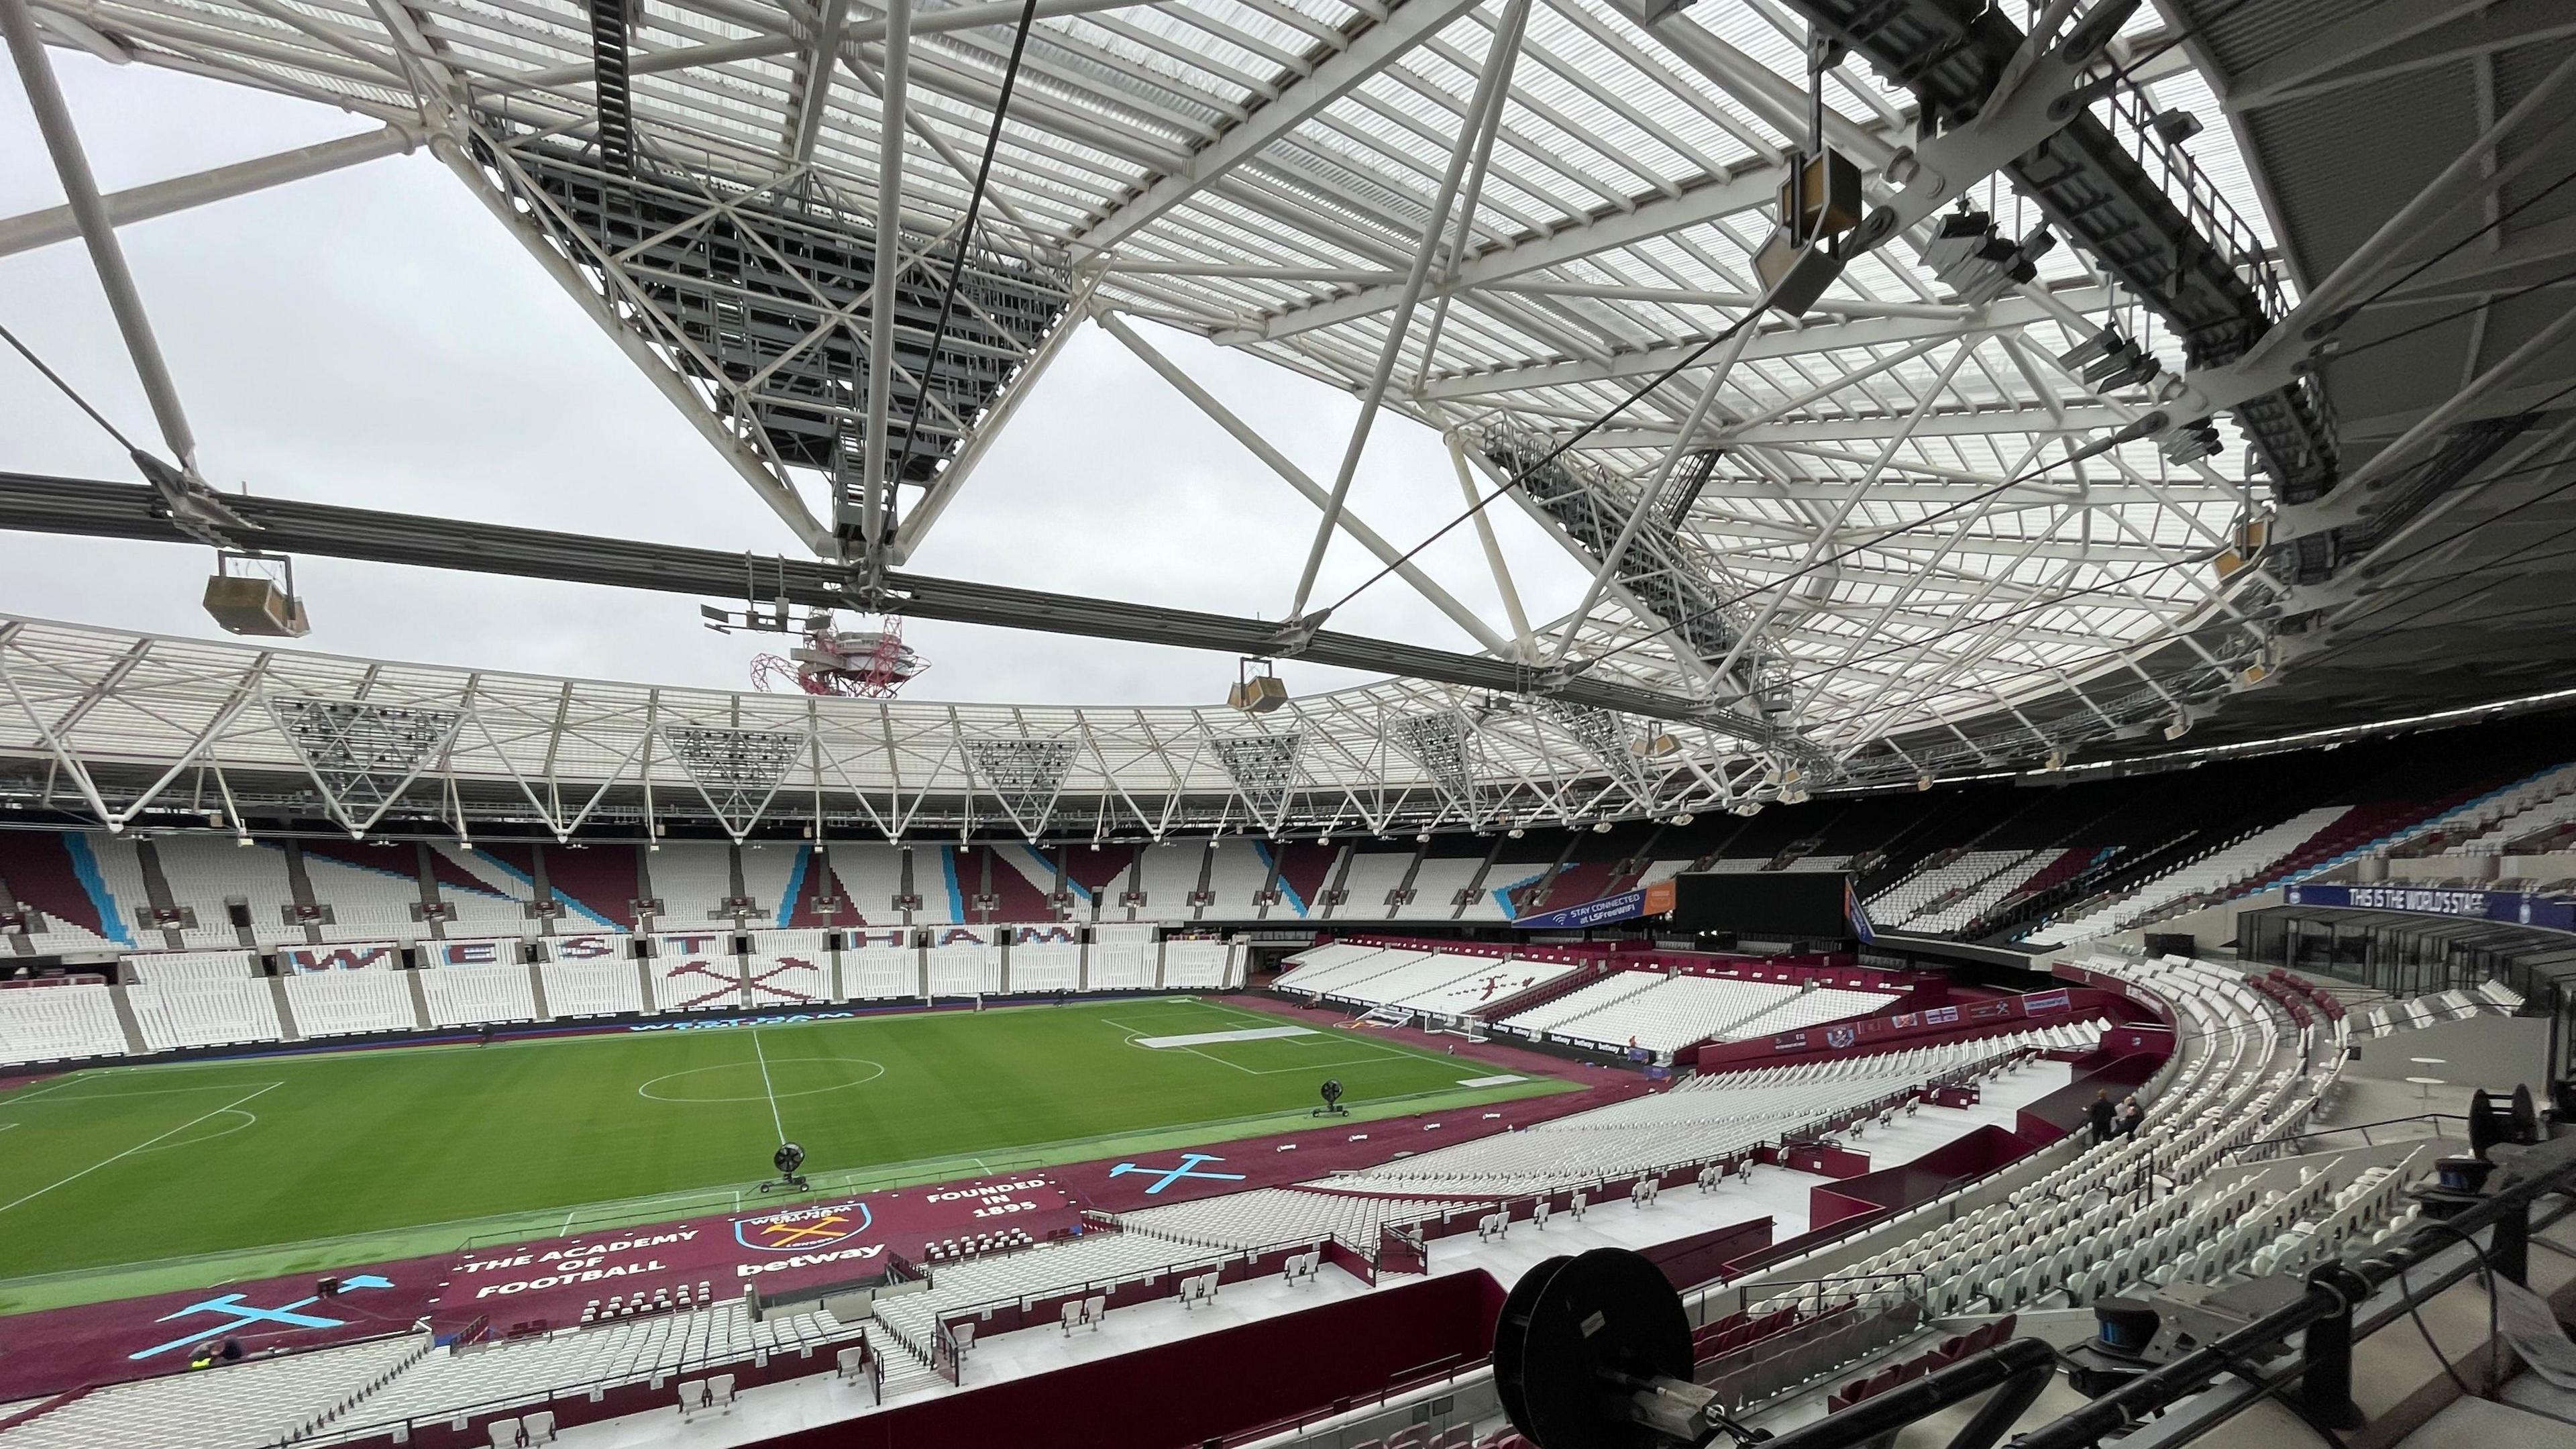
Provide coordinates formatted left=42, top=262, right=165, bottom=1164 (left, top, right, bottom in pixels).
left=0, top=0, right=2411, bottom=794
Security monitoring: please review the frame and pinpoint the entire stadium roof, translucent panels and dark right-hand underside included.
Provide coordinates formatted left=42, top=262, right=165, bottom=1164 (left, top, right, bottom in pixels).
left=0, top=0, right=2576, bottom=822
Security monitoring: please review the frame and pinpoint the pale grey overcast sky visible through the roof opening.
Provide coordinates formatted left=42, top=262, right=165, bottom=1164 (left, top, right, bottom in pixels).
left=0, top=49, right=1582, bottom=704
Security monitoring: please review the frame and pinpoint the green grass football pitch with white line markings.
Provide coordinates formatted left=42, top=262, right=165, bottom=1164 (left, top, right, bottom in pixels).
left=0, top=998, right=1566, bottom=1312
